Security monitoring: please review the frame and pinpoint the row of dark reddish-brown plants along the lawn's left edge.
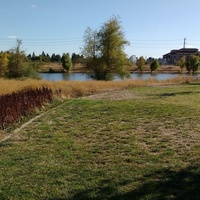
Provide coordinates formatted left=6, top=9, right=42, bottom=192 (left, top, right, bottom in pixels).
left=0, top=87, right=53, bottom=129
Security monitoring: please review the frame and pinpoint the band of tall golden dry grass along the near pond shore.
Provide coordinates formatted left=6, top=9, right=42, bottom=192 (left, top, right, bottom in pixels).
left=0, top=77, right=192, bottom=98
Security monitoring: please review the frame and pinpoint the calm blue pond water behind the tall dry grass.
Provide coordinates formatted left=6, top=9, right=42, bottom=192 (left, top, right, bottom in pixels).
left=40, top=73, right=200, bottom=81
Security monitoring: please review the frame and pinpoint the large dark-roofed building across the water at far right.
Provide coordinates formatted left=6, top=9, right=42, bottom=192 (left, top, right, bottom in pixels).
left=163, top=48, right=200, bottom=64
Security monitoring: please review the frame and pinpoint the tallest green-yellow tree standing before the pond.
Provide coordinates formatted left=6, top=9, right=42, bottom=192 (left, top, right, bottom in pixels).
left=82, top=17, right=130, bottom=80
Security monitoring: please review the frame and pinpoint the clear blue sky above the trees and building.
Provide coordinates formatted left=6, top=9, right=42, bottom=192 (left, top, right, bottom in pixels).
left=0, top=0, right=200, bottom=58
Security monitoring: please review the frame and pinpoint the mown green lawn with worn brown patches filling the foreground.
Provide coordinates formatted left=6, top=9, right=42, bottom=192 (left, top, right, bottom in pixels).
left=0, top=84, right=200, bottom=200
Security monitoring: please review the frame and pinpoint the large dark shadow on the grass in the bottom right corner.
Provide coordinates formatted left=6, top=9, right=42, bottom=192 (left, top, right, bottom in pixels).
left=71, top=167, right=200, bottom=200
